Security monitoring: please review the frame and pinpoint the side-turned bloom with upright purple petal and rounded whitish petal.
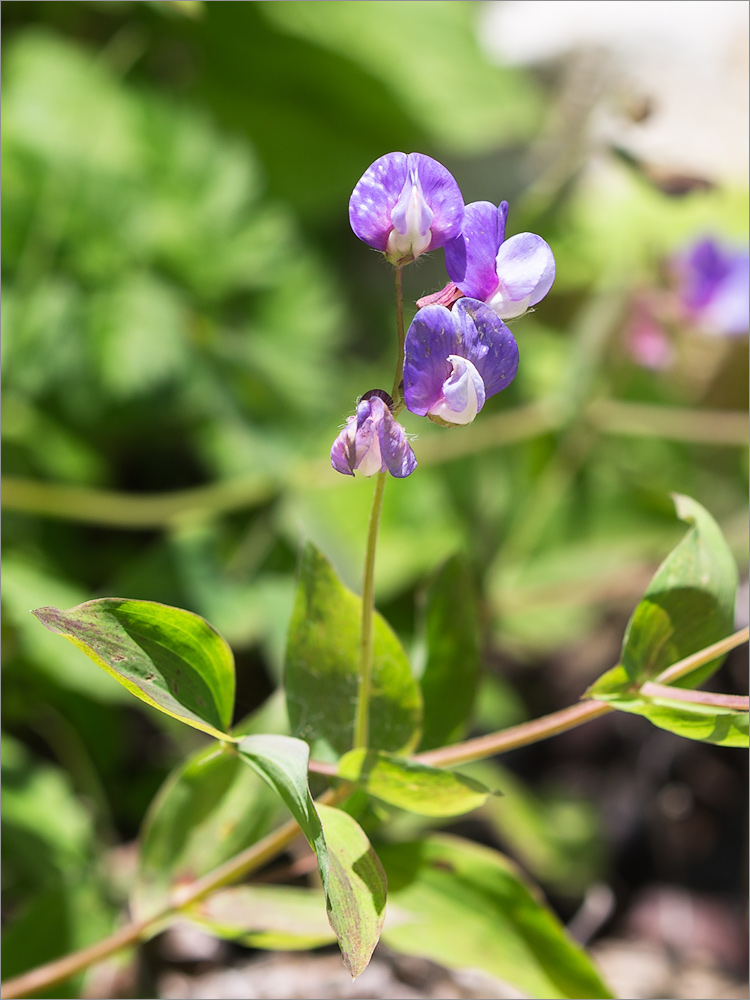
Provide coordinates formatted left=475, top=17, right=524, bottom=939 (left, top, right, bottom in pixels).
left=445, top=201, right=555, bottom=319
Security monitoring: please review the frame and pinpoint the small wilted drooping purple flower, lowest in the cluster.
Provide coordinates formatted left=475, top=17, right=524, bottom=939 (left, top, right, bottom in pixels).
left=331, top=389, right=417, bottom=479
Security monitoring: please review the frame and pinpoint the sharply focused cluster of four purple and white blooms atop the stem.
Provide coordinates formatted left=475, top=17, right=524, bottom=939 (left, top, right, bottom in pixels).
left=331, top=153, right=555, bottom=477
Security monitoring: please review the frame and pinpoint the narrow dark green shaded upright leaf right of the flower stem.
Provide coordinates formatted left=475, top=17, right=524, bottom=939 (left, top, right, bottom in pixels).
left=420, top=556, right=479, bottom=750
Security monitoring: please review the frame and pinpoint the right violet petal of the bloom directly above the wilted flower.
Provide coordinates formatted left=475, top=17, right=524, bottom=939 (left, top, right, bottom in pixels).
left=452, top=298, right=518, bottom=398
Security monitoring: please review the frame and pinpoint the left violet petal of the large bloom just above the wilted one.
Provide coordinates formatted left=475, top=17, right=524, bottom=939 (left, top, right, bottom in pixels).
left=404, top=299, right=464, bottom=417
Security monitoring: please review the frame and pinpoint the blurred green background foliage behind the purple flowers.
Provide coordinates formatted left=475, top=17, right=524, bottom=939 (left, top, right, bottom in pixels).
left=2, top=0, right=747, bottom=995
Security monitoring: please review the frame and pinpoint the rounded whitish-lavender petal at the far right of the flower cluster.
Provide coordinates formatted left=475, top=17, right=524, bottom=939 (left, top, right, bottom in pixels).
left=487, top=233, right=555, bottom=319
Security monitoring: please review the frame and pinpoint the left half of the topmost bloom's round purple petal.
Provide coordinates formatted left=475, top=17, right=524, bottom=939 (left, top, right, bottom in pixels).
left=349, top=153, right=414, bottom=252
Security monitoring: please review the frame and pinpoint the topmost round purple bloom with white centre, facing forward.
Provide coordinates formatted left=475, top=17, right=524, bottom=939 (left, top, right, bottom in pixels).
left=349, top=153, right=464, bottom=264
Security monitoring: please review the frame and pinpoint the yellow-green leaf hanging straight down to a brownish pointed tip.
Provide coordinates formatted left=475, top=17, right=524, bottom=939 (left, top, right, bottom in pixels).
left=318, top=805, right=386, bottom=978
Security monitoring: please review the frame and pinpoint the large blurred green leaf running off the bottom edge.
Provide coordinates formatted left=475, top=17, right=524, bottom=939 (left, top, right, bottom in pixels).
left=379, top=835, right=612, bottom=1000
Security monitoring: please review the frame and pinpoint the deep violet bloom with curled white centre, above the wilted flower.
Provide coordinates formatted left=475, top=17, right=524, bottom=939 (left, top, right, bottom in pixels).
left=404, top=298, right=518, bottom=425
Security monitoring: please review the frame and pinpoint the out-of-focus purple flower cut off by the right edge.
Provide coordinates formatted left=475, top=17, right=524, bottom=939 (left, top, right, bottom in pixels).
left=673, top=239, right=750, bottom=336
